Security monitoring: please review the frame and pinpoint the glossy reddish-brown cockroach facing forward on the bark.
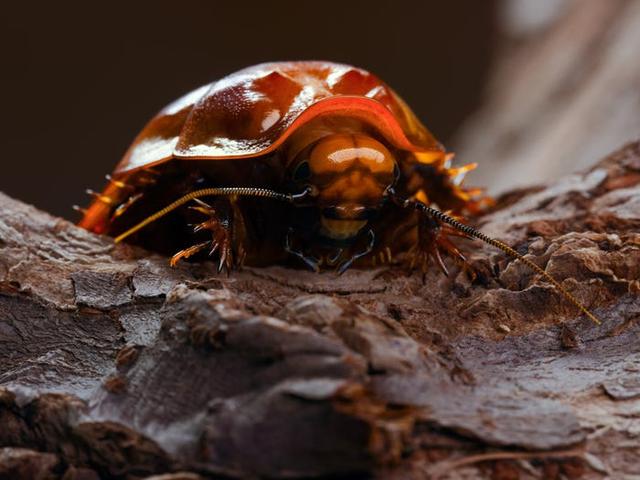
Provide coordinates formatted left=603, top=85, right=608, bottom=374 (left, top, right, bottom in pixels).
left=79, top=61, right=598, bottom=323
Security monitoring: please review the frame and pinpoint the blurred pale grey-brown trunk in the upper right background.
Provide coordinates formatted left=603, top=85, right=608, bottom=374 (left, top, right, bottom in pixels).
left=453, top=0, right=640, bottom=192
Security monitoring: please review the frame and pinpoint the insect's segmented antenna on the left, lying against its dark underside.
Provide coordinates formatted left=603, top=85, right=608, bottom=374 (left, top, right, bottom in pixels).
left=115, top=187, right=310, bottom=243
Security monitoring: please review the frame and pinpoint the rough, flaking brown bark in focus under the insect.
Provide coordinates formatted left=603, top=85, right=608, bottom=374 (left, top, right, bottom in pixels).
left=0, top=143, right=640, bottom=480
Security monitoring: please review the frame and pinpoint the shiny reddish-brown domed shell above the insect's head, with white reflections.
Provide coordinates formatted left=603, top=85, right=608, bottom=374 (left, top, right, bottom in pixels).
left=114, top=62, right=444, bottom=176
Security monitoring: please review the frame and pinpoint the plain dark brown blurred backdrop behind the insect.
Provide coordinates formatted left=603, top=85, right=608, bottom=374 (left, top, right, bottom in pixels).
left=0, top=0, right=497, bottom=219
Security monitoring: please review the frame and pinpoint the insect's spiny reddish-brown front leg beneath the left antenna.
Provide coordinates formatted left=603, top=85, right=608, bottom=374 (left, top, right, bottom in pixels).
left=170, top=197, right=246, bottom=272
